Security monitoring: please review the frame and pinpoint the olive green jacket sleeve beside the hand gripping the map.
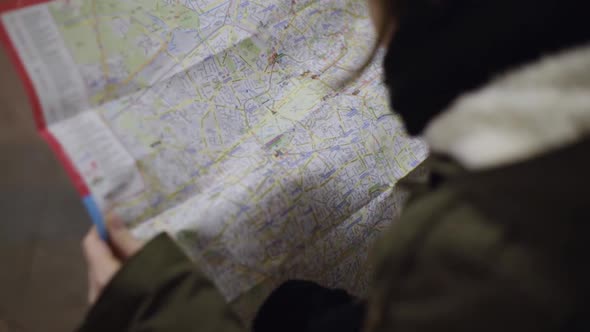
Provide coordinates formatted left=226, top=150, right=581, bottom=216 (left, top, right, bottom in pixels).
left=79, top=234, right=242, bottom=332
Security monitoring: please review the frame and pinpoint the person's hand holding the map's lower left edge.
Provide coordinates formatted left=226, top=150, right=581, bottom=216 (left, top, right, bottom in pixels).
left=82, top=215, right=144, bottom=304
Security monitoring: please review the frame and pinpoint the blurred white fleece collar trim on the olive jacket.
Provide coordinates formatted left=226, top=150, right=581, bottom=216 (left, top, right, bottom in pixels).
left=424, top=46, right=590, bottom=169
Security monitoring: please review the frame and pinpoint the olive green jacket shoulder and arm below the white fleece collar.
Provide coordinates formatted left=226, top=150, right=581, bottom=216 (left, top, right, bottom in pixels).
left=365, top=141, right=590, bottom=332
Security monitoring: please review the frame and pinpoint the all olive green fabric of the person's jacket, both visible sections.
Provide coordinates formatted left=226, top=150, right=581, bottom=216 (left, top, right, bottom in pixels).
left=80, top=141, right=590, bottom=332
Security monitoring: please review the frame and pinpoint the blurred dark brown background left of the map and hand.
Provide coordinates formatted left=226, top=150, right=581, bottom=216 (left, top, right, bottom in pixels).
left=0, top=39, right=90, bottom=332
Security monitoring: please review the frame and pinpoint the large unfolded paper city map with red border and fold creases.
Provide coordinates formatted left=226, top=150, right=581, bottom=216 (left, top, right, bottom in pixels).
left=1, top=0, right=427, bottom=300
